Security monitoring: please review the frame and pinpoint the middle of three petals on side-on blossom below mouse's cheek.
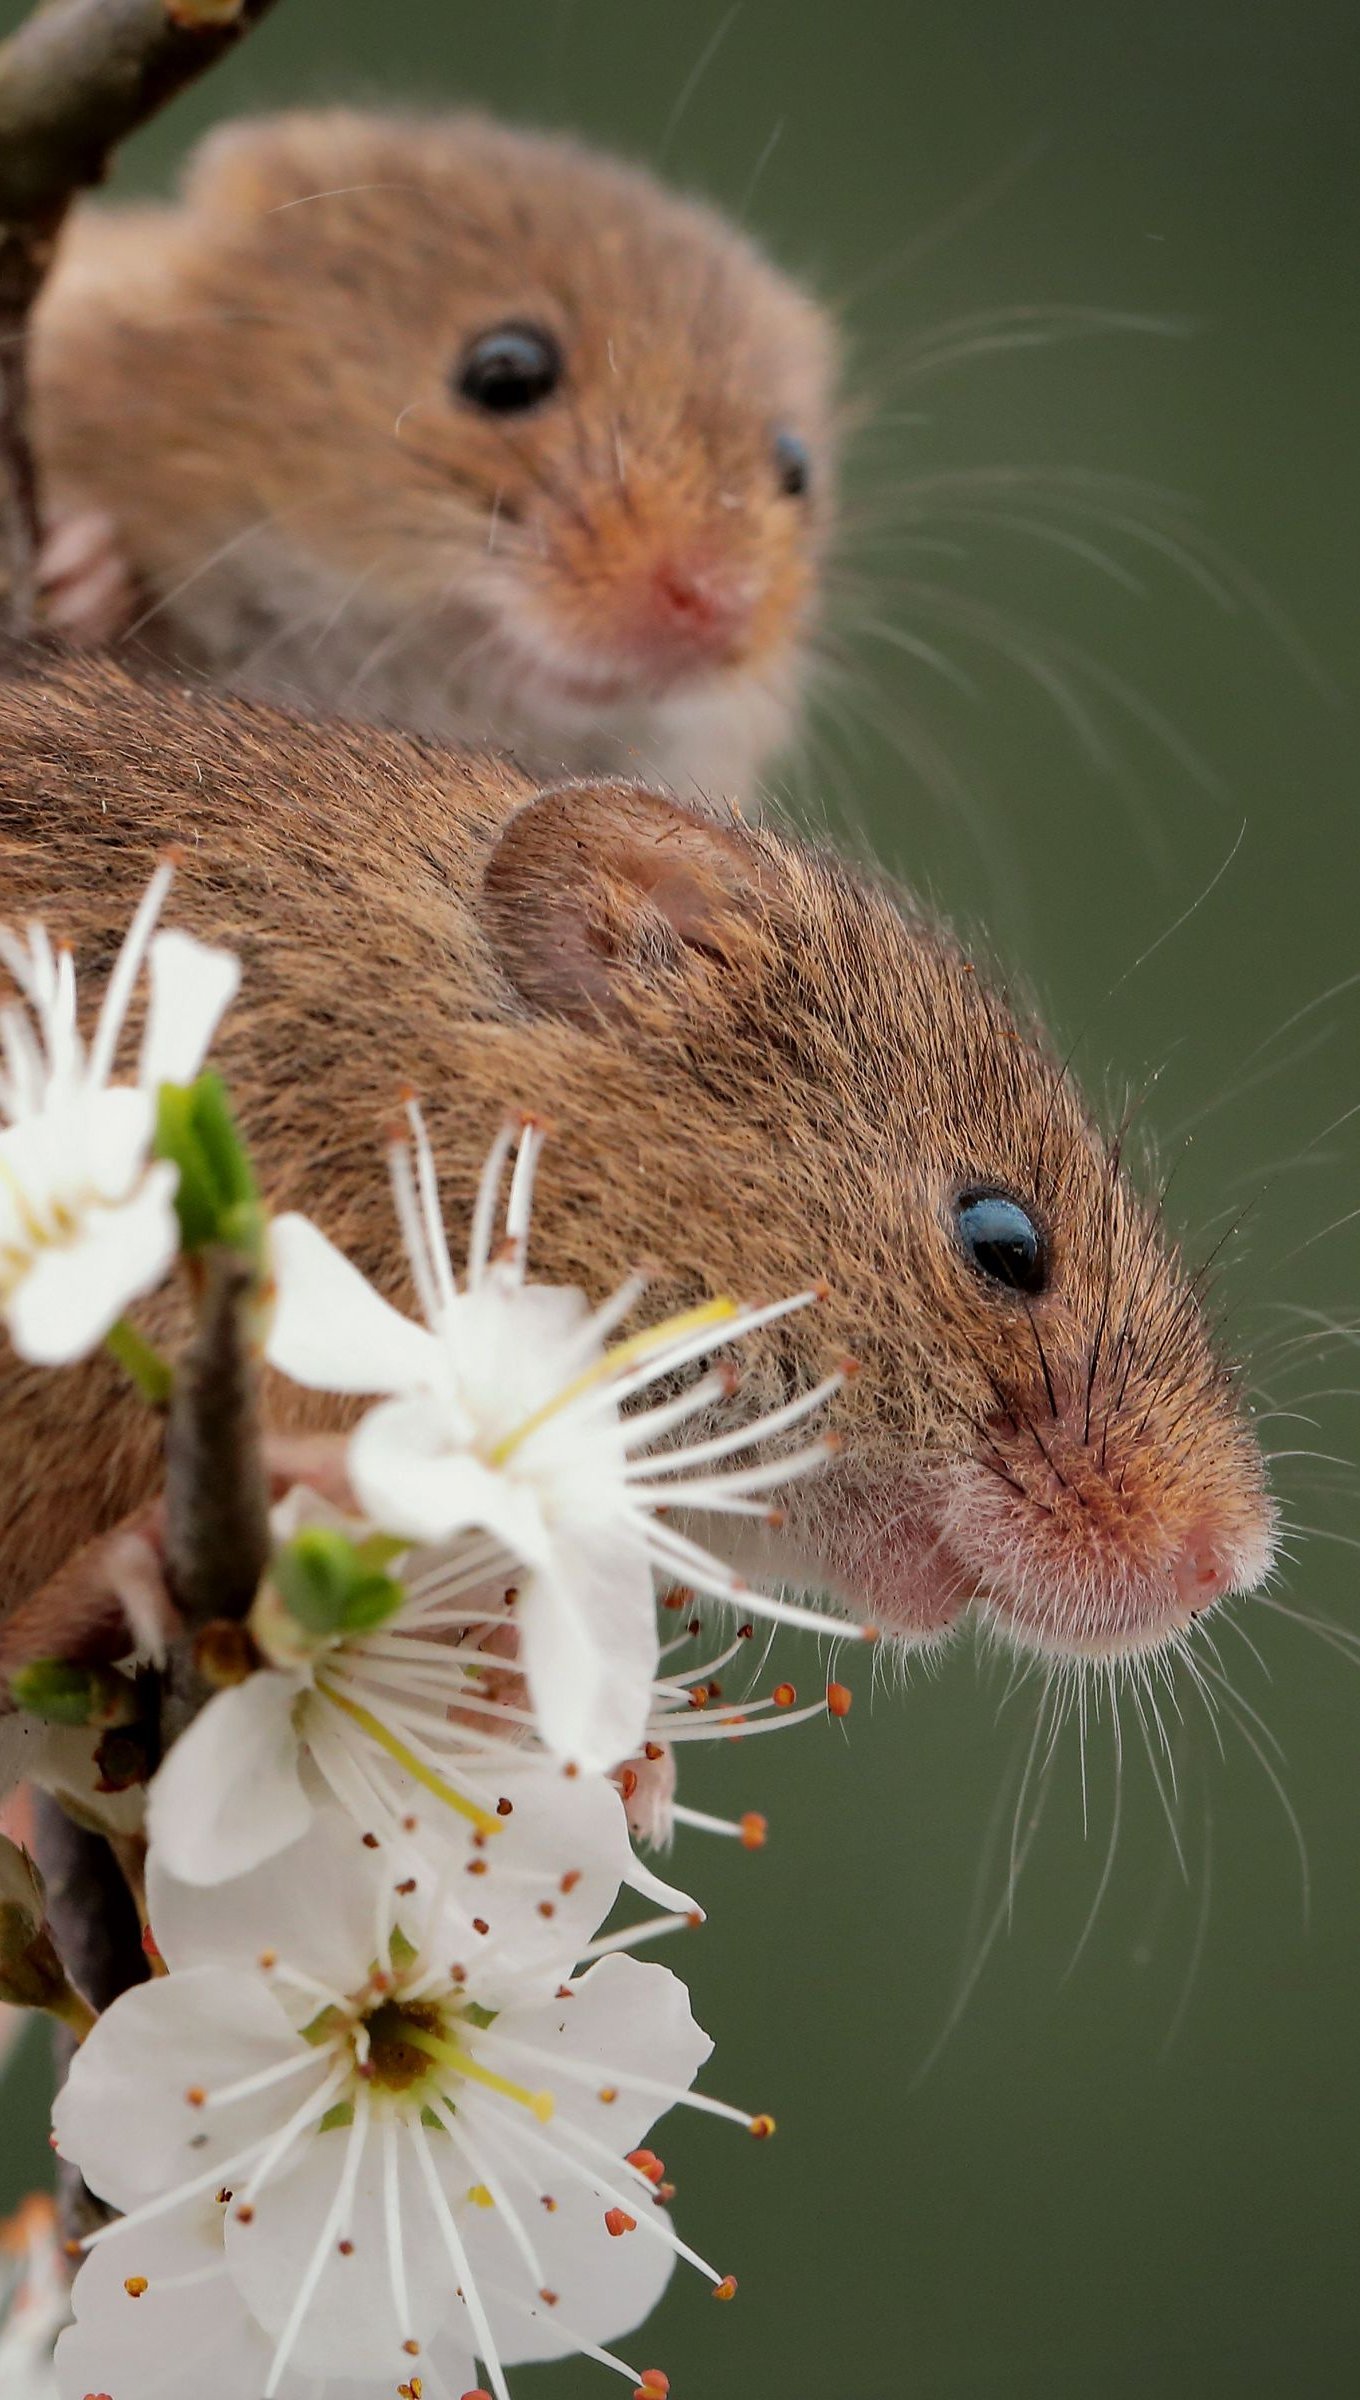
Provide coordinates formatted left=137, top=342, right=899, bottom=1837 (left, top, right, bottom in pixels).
left=348, top=1397, right=552, bottom=1567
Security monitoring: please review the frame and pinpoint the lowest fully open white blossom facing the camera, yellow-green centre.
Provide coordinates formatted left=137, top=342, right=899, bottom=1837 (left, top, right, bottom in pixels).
left=55, top=1804, right=768, bottom=2400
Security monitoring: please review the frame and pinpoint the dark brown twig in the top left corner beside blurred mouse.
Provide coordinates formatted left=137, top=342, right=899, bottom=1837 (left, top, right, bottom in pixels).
left=0, top=0, right=276, bottom=636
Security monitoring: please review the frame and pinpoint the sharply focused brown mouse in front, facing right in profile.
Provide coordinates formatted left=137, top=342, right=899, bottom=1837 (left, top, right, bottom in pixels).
left=0, top=665, right=1274, bottom=1656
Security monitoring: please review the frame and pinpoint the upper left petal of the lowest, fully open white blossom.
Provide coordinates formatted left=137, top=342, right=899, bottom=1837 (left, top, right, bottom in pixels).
left=146, top=1804, right=391, bottom=1992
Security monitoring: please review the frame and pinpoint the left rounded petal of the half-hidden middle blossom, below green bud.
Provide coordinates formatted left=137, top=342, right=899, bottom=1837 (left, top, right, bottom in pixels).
left=146, top=1670, right=312, bottom=1884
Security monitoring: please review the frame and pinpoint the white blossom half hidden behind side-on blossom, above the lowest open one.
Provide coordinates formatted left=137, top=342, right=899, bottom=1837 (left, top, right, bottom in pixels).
left=148, top=1486, right=849, bottom=1915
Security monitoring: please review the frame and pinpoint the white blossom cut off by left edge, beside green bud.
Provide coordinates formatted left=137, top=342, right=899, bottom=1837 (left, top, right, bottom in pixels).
left=0, top=866, right=240, bottom=1366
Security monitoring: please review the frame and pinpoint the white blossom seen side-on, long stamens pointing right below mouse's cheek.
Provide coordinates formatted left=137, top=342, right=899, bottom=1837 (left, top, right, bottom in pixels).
left=269, top=1109, right=863, bottom=1769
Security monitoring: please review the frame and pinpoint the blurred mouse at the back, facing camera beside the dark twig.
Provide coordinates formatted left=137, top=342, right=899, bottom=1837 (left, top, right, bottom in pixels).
left=34, top=110, right=835, bottom=797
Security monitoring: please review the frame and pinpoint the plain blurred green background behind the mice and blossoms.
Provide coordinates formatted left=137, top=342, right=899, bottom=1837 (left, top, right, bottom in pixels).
left=0, top=0, right=1360, bottom=2400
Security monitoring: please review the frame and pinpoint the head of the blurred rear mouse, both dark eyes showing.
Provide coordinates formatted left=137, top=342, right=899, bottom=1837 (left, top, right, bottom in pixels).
left=171, top=113, right=835, bottom=773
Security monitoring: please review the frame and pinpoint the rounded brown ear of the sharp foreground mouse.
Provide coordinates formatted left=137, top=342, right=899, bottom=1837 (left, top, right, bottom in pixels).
left=482, top=782, right=770, bottom=1022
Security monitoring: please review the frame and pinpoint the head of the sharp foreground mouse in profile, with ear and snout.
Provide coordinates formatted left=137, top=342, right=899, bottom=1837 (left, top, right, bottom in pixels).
left=485, top=787, right=1274, bottom=1656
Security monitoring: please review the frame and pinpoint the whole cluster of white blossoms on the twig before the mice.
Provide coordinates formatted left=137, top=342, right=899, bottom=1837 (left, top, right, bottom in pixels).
left=0, top=866, right=868, bottom=2400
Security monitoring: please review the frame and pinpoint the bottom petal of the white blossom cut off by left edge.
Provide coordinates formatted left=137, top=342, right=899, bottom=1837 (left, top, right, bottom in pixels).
left=7, top=1164, right=180, bottom=1366
